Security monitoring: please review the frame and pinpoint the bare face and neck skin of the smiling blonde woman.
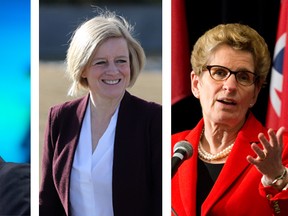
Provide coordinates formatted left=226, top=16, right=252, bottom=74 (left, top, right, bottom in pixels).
left=82, top=38, right=130, bottom=152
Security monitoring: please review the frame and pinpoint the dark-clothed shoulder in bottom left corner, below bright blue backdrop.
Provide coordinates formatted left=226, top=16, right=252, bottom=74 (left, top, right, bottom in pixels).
left=0, top=157, right=30, bottom=215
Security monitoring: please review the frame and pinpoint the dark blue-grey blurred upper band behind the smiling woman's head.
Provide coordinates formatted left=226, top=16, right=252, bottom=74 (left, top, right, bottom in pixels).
left=39, top=0, right=162, bottom=60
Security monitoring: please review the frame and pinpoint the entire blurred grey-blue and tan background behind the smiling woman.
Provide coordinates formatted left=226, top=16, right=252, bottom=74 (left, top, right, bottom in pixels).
left=39, top=0, right=162, bottom=160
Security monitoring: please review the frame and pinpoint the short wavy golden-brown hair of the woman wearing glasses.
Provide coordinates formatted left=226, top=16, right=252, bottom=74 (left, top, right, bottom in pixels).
left=191, top=23, right=271, bottom=85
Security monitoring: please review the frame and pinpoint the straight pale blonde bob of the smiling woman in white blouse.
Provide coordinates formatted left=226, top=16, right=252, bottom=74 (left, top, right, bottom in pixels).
left=66, top=11, right=146, bottom=96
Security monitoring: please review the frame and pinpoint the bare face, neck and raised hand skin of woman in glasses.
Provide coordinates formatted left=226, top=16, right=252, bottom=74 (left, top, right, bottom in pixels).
left=191, top=45, right=288, bottom=189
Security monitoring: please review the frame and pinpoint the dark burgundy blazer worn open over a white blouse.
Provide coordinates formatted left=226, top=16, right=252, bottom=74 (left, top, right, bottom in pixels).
left=40, top=92, right=162, bottom=216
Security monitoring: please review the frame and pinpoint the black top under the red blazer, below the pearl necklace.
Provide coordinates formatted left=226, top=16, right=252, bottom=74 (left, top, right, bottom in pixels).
left=196, top=158, right=224, bottom=215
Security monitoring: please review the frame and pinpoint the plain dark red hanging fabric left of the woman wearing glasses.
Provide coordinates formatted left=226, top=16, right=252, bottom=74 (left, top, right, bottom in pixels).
left=171, top=0, right=191, bottom=104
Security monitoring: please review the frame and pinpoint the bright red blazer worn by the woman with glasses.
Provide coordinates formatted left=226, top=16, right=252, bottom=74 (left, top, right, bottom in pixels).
left=172, top=113, right=288, bottom=216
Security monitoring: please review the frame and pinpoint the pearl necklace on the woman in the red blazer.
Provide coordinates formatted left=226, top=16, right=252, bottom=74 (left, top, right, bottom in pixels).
left=198, top=130, right=234, bottom=161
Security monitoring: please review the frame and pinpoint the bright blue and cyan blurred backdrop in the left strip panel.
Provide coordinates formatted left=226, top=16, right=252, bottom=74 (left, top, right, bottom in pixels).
left=0, top=0, right=30, bottom=162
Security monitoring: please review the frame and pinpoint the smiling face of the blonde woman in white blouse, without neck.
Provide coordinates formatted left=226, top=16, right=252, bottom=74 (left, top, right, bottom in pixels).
left=82, top=38, right=130, bottom=99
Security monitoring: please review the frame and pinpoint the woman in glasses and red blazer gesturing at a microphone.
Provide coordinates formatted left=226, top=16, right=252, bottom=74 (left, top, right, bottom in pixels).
left=172, top=24, right=288, bottom=216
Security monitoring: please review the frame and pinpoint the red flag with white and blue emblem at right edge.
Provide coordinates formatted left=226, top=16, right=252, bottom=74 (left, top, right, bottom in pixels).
left=266, top=0, right=288, bottom=130
